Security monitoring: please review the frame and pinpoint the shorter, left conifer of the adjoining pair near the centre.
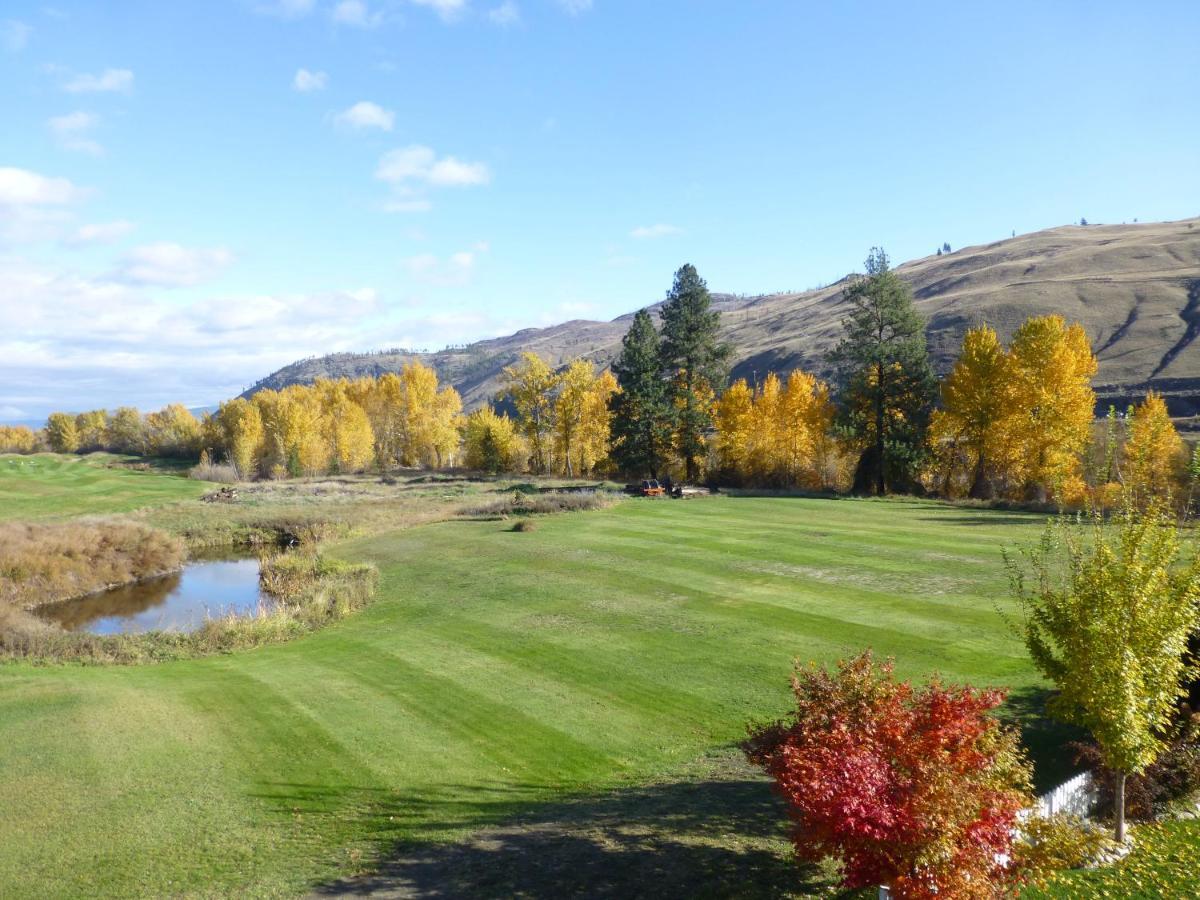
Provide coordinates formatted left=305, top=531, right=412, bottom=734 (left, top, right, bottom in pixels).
left=608, top=310, right=671, bottom=478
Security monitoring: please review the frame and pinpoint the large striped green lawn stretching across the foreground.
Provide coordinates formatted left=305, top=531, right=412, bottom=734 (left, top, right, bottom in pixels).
left=0, top=496, right=1063, bottom=896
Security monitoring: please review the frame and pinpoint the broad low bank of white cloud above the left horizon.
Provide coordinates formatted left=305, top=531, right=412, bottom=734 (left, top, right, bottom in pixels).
left=0, top=259, right=528, bottom=418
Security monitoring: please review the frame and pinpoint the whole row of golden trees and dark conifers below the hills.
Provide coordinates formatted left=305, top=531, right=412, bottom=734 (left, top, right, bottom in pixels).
left=14, top=250, right=1200, bottom=505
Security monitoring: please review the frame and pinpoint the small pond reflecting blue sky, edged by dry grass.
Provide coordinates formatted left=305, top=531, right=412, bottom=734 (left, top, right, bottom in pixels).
left=36, top=557, right=271, bottom=635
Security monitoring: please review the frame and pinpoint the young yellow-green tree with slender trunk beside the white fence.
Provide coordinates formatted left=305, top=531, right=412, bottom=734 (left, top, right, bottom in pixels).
left=1006, top=498, right=1200, bottom=840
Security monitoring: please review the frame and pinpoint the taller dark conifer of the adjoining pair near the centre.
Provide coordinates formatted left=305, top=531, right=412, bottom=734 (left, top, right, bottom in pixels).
left=659, top=265, right=730, bottom=480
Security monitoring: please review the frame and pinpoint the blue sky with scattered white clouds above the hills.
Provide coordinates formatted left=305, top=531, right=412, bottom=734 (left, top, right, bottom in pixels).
left=0, top=0, right=1200, bottom=421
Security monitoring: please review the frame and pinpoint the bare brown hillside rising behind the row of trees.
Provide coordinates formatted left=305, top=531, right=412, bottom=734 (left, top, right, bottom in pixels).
left=247, top=218, right=1200, bottom=416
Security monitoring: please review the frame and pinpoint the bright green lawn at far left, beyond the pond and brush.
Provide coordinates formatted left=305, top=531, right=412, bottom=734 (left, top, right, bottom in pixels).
left=0, top=454, right=212, bottom=521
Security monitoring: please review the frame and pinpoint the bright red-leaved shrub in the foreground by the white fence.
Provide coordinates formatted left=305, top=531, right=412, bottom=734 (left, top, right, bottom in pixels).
left=744, top=652, right=1032, bottom=900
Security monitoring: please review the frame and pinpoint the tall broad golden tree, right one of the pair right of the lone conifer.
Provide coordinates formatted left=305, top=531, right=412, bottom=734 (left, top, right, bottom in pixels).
left=1006, top=316, right=1097, bottom=500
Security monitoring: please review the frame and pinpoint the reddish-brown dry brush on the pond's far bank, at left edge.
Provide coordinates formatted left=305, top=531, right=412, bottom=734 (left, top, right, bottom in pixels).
left=0, top=522, right=187, bottom=610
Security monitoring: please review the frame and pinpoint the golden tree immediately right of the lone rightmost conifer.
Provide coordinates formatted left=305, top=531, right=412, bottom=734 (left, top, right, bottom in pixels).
left=930, top=325, right=1012, bottom=499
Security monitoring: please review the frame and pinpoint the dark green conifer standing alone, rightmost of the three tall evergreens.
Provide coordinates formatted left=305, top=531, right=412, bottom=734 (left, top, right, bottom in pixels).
left=834, top=247, right=937, bottom=494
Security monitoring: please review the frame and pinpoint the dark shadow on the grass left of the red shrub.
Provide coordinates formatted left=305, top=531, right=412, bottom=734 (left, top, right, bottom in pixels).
left=295, top=778, right=830, bottom=899
